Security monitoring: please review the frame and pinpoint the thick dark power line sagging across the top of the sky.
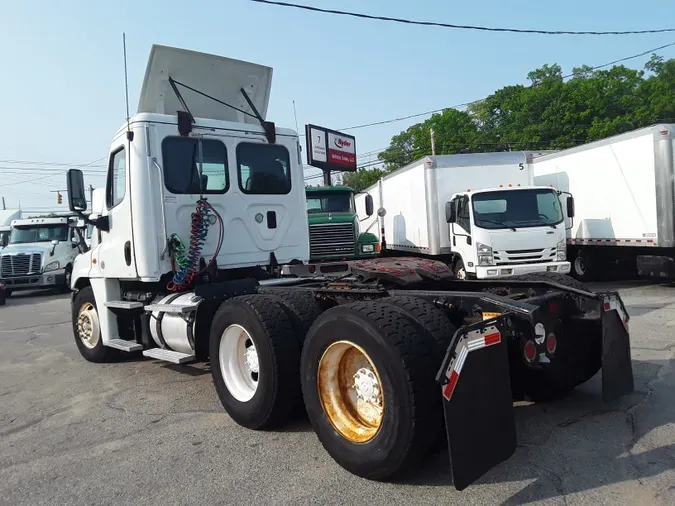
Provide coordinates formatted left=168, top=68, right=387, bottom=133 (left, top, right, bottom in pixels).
left=250, top=0, right=675, bottom=35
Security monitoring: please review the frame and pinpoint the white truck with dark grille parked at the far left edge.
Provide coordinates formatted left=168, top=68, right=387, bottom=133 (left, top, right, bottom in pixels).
left=0, top=217, right=79, bottom=294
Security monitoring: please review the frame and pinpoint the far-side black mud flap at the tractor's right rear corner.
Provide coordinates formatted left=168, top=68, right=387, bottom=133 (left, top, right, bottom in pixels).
left=602, top=293, right=634, bottom=401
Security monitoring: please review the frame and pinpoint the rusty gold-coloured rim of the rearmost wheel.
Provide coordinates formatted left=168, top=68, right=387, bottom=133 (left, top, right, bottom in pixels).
left=317, top=341, right=385, bottom=443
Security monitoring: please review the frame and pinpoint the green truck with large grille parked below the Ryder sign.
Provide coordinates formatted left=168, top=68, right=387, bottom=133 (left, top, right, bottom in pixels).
left=305, top=186, right=380, bottom=266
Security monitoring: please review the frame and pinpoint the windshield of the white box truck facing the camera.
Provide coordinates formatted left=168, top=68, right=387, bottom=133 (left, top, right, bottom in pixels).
left=473, top=189, right=563, bottom=229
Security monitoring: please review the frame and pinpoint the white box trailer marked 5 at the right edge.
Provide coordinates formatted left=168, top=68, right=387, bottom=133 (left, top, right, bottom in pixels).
left=533, top=124, right=675, bottom=280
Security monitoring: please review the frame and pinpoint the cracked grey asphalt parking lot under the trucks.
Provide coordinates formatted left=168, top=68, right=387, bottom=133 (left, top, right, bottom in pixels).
left=0, top=282, right=675, bottom=506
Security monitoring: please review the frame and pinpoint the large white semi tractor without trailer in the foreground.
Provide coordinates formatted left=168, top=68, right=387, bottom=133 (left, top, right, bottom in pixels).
left=67, top=46, right=633, bottom=489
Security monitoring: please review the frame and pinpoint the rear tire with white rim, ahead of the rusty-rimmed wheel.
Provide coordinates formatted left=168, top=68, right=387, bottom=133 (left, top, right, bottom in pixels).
left=209, top=295, right=301, bottom=429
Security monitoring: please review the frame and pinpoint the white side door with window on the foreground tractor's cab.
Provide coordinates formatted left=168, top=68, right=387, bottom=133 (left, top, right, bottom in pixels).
left=94, top=138, right=136, bottom=279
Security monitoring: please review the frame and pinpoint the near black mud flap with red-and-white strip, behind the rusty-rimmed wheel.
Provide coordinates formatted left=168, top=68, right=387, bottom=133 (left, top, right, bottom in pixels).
left=437, top=316, right=516, bottom=490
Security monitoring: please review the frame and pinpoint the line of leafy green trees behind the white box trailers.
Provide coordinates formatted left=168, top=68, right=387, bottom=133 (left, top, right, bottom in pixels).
left=344, top=55, right=675, bottom=191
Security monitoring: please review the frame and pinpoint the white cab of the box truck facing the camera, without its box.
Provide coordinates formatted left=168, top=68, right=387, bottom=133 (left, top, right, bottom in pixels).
left=445, top=186, right=574, bottom=279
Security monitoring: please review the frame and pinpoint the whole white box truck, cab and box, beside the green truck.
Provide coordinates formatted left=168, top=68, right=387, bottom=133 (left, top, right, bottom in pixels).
left=357, top=152, right=574, bottom=279
